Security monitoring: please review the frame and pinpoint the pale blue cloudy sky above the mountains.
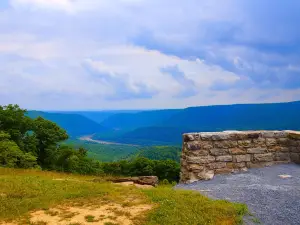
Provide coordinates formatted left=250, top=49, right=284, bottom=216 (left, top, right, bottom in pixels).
left=0, top=0, right=300, bottom=110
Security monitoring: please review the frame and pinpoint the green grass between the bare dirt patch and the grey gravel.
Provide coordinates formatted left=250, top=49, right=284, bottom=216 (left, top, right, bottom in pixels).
left=143, top=186, right=248, bottom=225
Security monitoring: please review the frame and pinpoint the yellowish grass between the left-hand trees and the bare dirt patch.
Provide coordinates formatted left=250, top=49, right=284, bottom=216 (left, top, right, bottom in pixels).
left=0, top=168, right=145, bottom=220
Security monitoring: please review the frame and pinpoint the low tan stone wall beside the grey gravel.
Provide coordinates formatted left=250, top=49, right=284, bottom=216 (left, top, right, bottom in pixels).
left=180, top=131, right=300, bottom=183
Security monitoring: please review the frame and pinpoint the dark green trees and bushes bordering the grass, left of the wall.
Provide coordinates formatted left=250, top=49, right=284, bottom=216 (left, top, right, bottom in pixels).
left=0, top=105, right=179, bottom=181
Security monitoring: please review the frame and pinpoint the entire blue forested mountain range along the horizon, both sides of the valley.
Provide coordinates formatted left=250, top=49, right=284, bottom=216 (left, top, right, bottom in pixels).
left=29, top=101, right=300, bottom=145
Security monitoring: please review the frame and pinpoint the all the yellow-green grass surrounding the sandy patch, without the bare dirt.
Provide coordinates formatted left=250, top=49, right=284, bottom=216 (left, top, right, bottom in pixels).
left=0, top=168, right=247, bottom=225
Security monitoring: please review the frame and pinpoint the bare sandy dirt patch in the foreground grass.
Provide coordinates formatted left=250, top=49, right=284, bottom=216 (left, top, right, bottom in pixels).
left=0, top=203, right=152, bottom=225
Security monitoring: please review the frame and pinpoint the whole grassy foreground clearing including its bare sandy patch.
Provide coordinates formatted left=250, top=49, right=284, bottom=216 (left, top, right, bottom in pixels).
left=0, top=168, right=247, bottom=225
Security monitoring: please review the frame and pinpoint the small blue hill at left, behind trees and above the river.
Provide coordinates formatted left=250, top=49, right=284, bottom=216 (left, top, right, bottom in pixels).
left=27, top=111, right=109, bottom=138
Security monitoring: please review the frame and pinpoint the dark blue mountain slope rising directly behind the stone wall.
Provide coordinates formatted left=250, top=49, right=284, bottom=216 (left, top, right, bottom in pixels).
left=162, top=101, right=300, bottom=131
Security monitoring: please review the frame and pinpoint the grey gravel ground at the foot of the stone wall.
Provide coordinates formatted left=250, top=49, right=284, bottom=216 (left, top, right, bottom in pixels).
left=176, top=164, right=300, bottom=225
